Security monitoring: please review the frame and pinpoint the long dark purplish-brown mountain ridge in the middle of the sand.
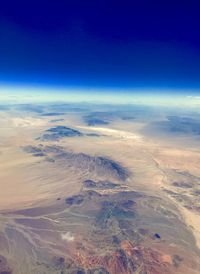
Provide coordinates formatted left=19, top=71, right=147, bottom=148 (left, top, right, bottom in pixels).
left=23, top=144, right=129, bottom=181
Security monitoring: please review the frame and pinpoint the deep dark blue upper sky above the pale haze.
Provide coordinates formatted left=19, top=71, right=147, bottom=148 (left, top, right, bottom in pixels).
left=0, top=0, right=200, bottom=88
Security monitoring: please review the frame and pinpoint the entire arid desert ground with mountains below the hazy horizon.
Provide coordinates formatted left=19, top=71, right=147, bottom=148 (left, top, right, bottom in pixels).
left=0, top=103, right=200, bottom=274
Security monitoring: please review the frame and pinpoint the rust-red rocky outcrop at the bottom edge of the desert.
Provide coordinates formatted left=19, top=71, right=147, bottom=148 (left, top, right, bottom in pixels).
left=76, top=241, right=173, bottom=274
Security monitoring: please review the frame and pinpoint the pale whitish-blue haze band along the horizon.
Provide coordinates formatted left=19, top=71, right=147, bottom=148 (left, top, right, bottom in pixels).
left=0, top=85, right=200, bottom=109
